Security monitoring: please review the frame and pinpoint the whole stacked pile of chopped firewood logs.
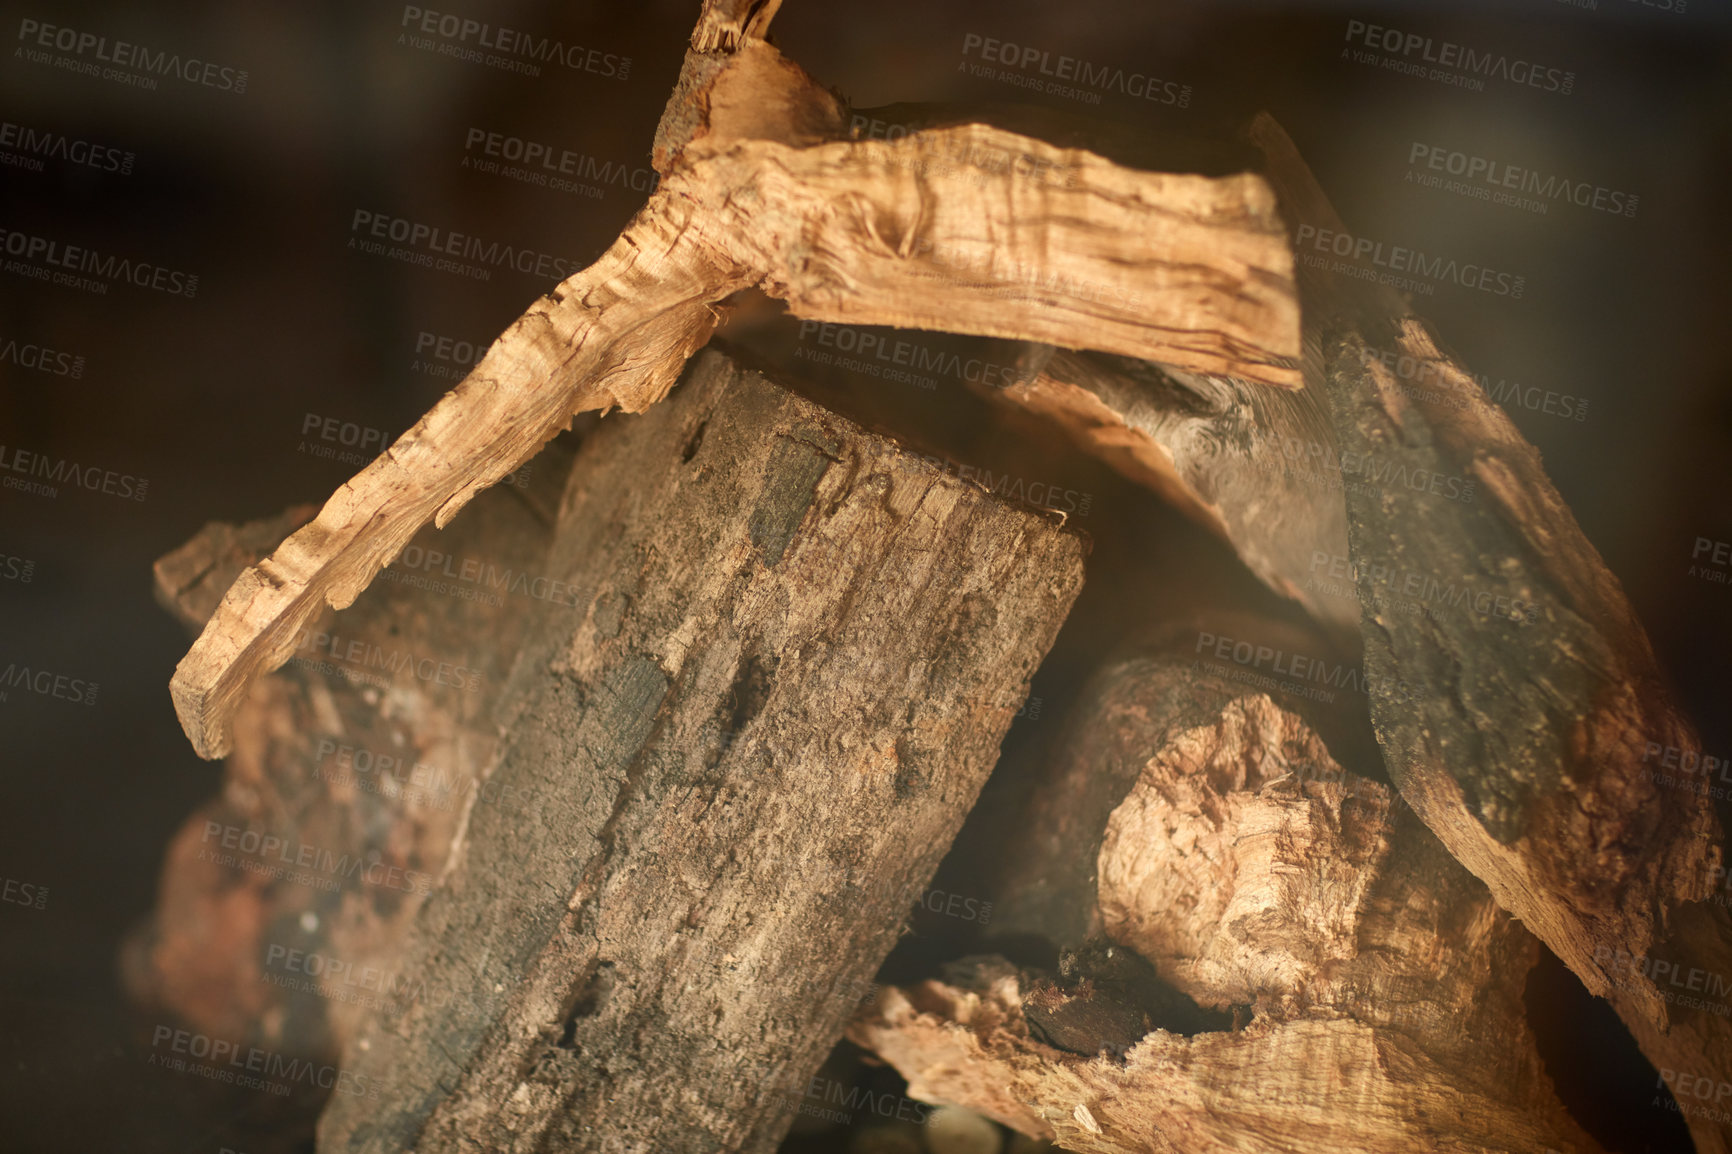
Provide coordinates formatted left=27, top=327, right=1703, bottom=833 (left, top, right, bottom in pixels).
left=128, top=0, right=1732, bottom=1154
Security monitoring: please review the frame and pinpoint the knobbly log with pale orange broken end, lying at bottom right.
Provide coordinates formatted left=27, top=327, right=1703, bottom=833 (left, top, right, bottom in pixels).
left=849, top=660, right=1599, bottom=1154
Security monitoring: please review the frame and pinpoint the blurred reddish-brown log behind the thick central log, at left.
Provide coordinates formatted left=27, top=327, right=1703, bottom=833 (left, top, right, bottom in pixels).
left=123, top=444, right=575, bottom=1066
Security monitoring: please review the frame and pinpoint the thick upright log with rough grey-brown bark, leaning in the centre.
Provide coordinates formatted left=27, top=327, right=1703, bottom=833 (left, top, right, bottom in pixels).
left=320, top=353, right=1083, bottom=1152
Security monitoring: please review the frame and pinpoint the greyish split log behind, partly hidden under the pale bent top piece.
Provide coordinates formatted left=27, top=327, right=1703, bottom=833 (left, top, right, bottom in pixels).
left=803, top=104, right=1360, bottom=634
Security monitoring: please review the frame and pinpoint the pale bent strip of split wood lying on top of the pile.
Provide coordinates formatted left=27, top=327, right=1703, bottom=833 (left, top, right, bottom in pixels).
left=171, top=3, right=1299, bottom=757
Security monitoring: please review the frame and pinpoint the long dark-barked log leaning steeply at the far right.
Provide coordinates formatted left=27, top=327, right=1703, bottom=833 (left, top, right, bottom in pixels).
left=1252, top=110, right=1732, bottom=1154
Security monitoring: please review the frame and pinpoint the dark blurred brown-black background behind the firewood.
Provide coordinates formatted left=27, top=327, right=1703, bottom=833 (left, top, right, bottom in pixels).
left=0, top=0, right=1732, bottom=1154
